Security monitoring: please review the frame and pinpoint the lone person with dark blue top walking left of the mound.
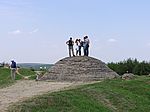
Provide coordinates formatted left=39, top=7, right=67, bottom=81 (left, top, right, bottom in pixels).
left=10, top=60, right=17, bottom=80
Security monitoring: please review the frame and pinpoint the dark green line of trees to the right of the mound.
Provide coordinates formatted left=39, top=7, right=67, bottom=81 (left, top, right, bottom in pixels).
left=108, top=58, right=150, bottom=75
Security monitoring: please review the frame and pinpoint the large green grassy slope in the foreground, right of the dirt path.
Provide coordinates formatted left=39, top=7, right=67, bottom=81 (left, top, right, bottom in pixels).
left=9, top=77, right=150, bottom=112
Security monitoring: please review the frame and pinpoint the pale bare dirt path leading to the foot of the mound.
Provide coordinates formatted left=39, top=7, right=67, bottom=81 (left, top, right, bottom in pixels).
left=0, top=80, right=82, bottom=112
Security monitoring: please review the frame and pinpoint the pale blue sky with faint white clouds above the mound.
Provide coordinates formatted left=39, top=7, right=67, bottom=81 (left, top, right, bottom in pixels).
left=0, top=0, right=150, bottom=63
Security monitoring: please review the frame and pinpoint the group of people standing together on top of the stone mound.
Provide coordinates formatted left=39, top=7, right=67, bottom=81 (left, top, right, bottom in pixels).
left=66, top=36, right=90, bottom=57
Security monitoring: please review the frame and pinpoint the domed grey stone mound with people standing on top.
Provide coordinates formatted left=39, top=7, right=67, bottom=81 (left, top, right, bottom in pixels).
left=41, top=56, right=119, bottom=82
